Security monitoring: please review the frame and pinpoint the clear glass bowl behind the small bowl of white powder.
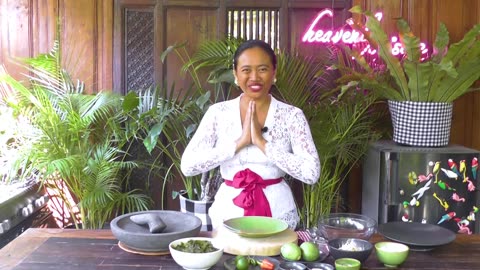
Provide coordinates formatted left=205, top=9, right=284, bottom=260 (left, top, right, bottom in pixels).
left=318, top=213, right=377, bottom=240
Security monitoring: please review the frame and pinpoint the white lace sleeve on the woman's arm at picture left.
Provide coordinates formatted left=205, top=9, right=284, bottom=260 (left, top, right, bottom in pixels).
left=181, top=106, right=236, bottom=176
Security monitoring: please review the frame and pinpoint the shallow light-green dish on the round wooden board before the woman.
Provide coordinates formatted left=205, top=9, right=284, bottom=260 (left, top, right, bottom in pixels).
left=223, top=216, right=288, bottom=238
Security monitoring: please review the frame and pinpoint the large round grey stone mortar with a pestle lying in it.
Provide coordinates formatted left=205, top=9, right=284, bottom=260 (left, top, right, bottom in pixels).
left=110, top=210, right=202, bottom=252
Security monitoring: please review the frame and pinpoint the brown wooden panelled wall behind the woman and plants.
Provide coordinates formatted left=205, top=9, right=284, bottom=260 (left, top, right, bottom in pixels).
left=0, top=0, right=480, bottom=211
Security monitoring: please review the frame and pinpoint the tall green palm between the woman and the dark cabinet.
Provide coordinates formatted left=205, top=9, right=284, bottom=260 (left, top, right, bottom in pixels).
left=276, top=46, right=383, bottom=228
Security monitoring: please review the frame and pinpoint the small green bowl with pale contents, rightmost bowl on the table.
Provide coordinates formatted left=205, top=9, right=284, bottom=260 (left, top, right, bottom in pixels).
left=375, top=242, right=410, bottom=267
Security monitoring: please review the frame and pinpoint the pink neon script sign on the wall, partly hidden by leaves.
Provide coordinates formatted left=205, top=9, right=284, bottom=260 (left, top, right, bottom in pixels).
left=302, top=9, right=428, bottom=60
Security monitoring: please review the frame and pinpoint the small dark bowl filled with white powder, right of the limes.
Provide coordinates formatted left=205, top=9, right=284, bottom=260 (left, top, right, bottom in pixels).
left=328, top=238, right=373, bottom=263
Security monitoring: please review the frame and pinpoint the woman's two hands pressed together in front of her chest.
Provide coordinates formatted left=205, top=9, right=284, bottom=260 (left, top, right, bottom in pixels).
left=235, top=100, right=267, bottom=153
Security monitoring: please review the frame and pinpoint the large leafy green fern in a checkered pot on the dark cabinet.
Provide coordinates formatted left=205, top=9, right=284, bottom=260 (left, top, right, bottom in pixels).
left=345, top=6, right=480, bottom=146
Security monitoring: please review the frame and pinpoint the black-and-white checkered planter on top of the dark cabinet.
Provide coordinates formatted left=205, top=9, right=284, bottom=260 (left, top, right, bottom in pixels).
left=388, top=100, right=453, bottom=147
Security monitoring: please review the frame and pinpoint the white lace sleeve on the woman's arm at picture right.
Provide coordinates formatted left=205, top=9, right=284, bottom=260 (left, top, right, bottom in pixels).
left=265, top=108, right=320, bottom=184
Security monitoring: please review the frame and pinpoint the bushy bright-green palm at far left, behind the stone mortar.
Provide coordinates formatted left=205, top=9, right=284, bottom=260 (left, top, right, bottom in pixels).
left=0, top=40, right=150, bottom=229
